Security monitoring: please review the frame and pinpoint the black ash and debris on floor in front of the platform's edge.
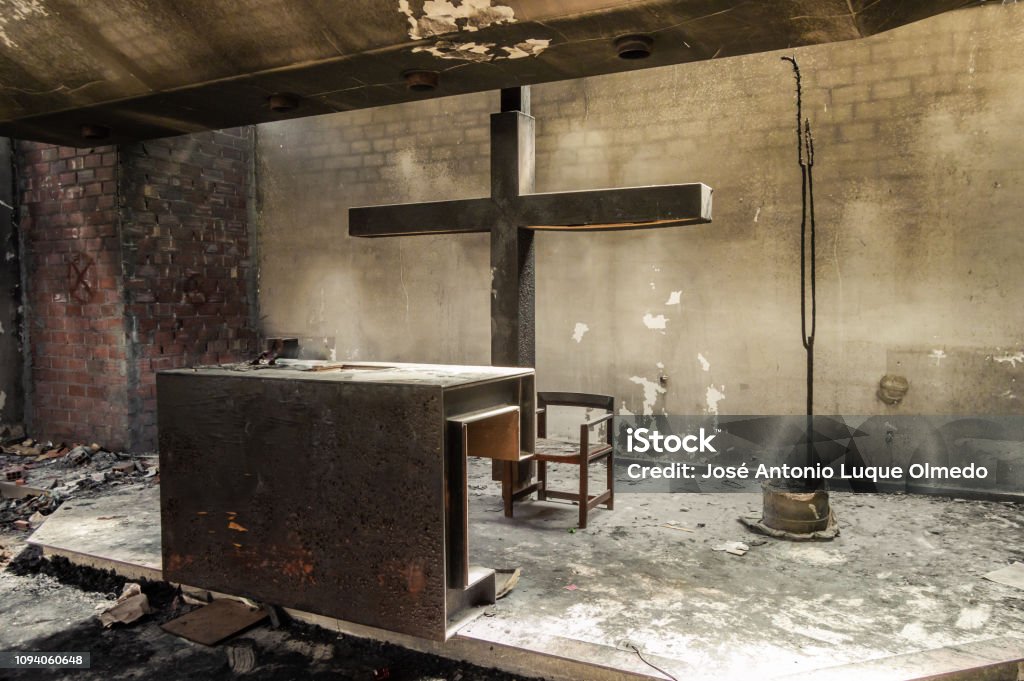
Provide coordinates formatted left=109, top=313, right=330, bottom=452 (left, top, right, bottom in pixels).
left=0, top=548, right=544, bottom=681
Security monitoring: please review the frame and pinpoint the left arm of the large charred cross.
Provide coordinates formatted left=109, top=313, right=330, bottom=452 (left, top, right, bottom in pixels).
left=348, top=199, right=498, bottom=237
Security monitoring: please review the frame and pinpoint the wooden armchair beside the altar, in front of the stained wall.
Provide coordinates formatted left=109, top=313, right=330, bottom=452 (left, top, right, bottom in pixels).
left=502, top=392, right=615, bottom=529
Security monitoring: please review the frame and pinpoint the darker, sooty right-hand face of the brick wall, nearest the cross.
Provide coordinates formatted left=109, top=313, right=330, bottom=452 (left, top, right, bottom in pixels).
left=121, top=128, right=256, bottom=449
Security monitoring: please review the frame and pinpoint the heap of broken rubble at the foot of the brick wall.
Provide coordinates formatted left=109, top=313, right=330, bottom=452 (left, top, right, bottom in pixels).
left=0, top=431, right=159, bottom=530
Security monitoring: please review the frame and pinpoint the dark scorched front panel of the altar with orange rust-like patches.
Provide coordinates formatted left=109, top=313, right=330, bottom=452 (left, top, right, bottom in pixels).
left=157, top=373, right=445, bottom=639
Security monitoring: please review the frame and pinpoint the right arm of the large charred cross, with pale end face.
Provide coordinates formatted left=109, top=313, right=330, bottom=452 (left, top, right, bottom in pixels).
left=519, top=182, right=712, bottom=229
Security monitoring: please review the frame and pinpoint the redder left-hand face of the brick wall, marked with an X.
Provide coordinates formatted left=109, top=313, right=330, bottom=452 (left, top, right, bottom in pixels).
left=18, top=142, right=128, bottom=448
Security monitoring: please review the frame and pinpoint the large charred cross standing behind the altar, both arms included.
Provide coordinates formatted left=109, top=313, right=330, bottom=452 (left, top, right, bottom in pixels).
left=348, top=87, right=712, bottom=367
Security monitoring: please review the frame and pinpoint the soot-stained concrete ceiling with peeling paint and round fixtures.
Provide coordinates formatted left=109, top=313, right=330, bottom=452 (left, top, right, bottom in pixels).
left=0, top=0, right=981, bottom=145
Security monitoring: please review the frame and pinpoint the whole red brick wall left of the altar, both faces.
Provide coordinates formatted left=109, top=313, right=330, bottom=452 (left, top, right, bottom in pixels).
left=17, top=129, right=255, bottom=451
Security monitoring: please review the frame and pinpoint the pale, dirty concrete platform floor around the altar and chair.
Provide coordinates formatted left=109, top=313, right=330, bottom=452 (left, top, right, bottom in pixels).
left=8, top=460, right=1024, bottom=679
